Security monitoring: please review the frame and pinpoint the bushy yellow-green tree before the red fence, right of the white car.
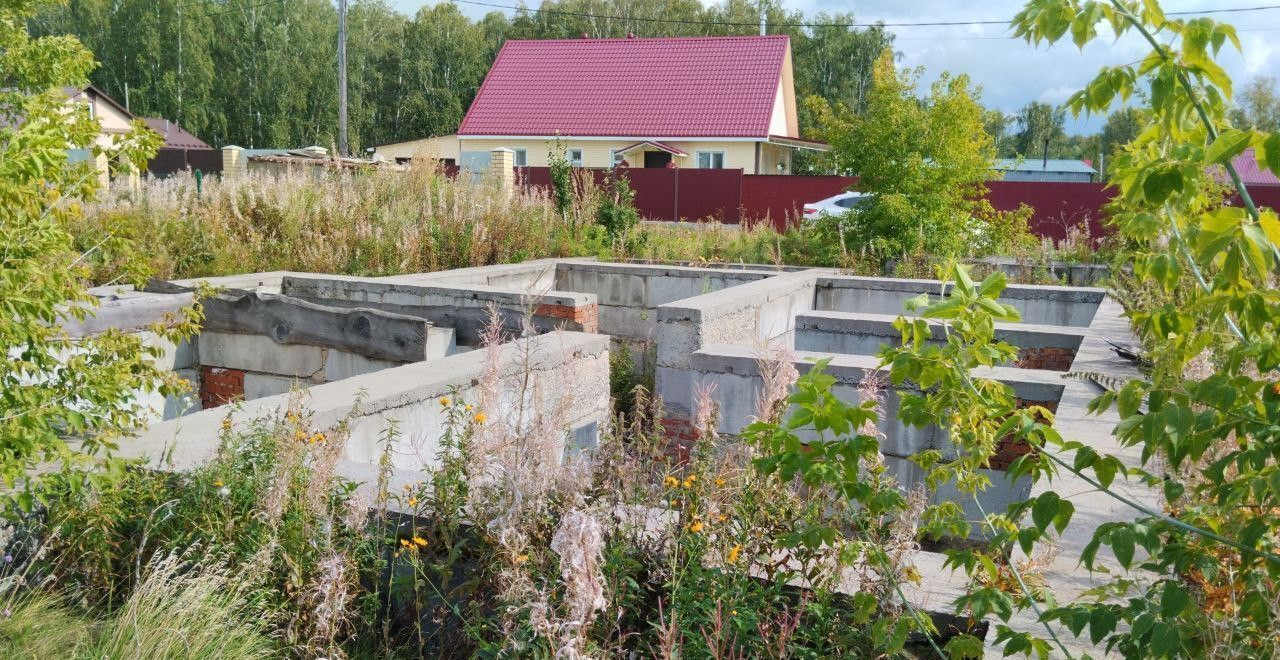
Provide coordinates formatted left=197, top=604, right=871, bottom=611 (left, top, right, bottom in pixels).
left=808, top=51, right=995, bottom=258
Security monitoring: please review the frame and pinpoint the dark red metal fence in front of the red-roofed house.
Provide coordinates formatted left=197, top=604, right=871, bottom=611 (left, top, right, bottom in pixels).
left=517, top=168, right=1280, bottom=239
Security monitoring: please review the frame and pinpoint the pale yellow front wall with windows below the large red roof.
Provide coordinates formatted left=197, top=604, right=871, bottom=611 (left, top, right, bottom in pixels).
left=458, top=138, right=771, bottom=174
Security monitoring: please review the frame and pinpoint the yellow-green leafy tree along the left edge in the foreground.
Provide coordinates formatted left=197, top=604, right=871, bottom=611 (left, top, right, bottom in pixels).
left=0, top=0, right=192, bottom=509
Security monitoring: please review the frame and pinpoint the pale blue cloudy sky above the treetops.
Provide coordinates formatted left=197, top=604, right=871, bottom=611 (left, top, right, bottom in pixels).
left=392, top=0, right=1280, bottom=133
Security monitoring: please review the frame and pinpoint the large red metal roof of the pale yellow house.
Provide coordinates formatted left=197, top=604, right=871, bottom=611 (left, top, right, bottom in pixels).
left=458, top=35, right=790, bottom=138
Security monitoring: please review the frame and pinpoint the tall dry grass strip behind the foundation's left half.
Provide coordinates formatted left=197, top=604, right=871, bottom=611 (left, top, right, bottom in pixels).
left=72, top=166, right=599, bottom=281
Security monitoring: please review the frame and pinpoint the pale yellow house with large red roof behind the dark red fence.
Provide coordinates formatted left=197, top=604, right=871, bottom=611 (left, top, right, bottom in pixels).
left=378, top=35, right=826, bottom=174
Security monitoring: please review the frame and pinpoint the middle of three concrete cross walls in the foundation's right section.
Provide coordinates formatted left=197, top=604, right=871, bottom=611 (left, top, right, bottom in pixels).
left=795, top=312, right=1085, bottom=371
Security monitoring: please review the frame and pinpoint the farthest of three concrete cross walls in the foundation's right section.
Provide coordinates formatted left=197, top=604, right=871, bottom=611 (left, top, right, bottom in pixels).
left=815, top=276, right=1106, bottom=327
